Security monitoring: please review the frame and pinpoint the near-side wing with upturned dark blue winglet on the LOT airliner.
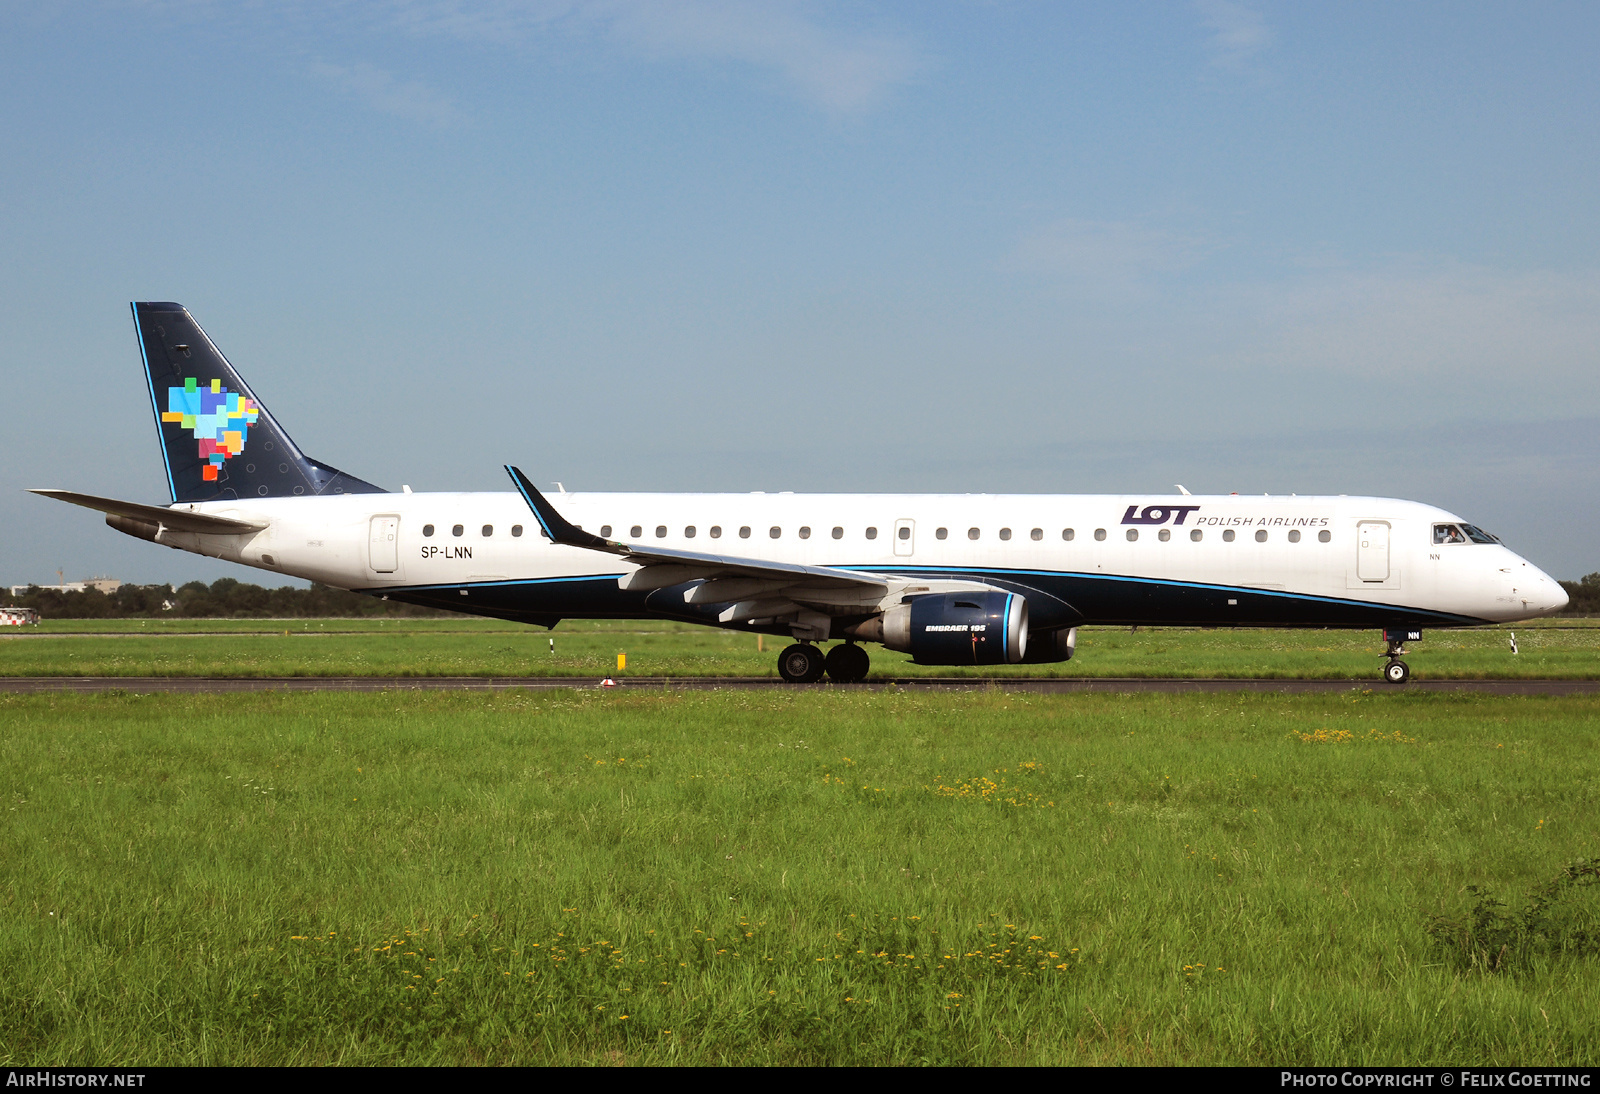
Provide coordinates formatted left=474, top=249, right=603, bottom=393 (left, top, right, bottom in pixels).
left=506, top=464, right=891, bottom=603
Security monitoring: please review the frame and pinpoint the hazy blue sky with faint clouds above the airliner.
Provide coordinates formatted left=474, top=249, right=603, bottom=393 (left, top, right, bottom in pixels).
left=0, top=0, right=1600, bottom=584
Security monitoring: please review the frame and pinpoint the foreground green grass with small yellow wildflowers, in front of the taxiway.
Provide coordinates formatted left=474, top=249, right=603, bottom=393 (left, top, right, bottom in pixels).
left=0, top=687, right=1600, bottom=1067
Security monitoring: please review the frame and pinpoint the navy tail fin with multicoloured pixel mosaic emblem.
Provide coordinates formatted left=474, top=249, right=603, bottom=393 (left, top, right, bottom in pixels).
left=131, top=302, right=386, bottom=502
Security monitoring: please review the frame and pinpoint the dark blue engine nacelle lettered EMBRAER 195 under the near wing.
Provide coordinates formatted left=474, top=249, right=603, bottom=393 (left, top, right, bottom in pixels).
left=862, top=592, right=1027, bottom=665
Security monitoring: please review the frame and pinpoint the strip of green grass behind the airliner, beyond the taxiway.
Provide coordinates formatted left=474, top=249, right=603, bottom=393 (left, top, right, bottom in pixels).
left=0, top=617, right=1600, bottom=680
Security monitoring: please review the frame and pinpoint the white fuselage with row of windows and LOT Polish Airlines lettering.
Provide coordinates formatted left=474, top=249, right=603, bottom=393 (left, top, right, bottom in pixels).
left=144, top=493, right=1566, bottom=625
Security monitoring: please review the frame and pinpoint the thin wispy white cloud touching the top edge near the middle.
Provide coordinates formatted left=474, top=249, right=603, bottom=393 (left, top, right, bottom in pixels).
left=376, top=0, right=922, bottom=112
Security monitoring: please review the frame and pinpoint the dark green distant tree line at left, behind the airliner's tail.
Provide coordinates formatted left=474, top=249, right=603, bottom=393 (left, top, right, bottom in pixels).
left=0, top=577, right=451, bottom=619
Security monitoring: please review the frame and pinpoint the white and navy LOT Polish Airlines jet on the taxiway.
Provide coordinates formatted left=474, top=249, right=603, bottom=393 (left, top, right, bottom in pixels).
left=34, top=302, right=1566, bottom=683
